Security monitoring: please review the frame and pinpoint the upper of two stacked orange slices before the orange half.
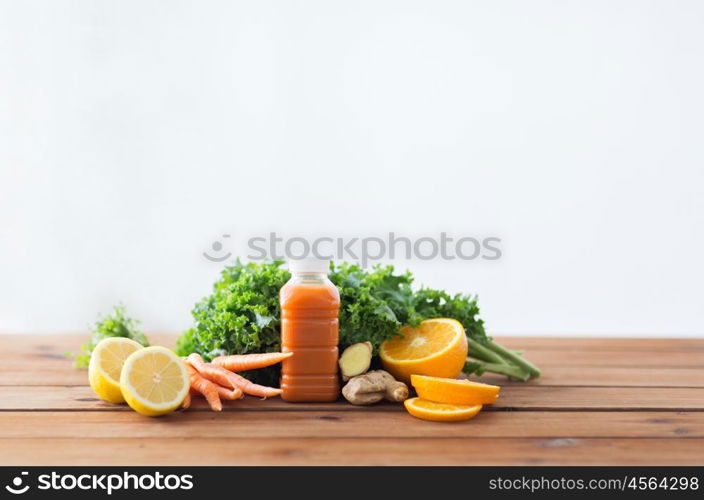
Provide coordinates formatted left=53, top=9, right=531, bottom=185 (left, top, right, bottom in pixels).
left=411, top=375, right=501, bottom=406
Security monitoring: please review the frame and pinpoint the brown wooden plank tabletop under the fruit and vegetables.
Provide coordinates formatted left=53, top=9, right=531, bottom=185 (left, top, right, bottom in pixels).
left=0, top=335, right=704, bottom=465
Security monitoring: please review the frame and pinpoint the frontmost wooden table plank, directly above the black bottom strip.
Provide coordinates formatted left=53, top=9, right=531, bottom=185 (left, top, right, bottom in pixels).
left=0, top=437, right=704, bottom=465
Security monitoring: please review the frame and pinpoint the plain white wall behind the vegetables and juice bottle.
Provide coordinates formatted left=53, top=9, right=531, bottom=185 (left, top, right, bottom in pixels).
left=0, top=0, right=704, bottom=336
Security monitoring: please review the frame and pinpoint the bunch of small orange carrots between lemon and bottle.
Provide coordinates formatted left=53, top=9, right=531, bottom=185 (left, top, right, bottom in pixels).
left=182, top=352, right=293, bottom=411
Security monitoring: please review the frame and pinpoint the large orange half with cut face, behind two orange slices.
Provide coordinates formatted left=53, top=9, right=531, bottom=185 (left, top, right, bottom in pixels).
left=379, top=318, right=467, bottom=383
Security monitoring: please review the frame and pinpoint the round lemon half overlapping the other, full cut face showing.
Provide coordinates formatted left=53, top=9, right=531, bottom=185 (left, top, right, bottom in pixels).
left=120, top=346, right=189, bottom=417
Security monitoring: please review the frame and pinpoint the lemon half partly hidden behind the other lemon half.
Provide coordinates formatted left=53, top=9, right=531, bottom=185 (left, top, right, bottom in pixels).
left=88, top=337, right=143, bottom=403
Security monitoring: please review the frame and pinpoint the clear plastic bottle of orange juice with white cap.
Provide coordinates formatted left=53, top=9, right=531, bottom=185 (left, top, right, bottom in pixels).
left=279, top=260, right=340, bottom=402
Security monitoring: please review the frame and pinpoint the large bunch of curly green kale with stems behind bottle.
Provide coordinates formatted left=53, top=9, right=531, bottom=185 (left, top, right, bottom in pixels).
left=176, top=260, right=540, bottom=385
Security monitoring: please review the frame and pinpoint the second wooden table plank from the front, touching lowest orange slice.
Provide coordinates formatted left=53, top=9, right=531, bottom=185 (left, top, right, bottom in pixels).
left=0, top=410, right=704, bottom=439
